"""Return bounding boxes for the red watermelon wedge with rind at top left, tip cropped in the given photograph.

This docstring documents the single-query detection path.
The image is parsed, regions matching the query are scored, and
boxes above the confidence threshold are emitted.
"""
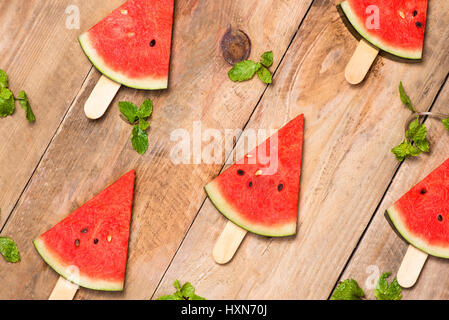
[79,0,174,90]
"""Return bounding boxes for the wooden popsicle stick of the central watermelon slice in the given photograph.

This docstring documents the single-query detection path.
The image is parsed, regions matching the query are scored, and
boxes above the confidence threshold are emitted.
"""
[212,221,248,264]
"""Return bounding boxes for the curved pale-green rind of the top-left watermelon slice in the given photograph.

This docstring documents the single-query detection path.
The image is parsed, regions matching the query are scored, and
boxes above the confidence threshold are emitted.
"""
[78,32,168,90]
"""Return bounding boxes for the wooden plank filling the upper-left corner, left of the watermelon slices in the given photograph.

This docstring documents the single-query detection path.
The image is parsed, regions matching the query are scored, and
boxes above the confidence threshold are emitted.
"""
[0,0,121,230]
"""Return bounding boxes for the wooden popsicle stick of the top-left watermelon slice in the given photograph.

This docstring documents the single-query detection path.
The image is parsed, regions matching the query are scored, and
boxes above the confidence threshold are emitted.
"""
[84,76,121,120]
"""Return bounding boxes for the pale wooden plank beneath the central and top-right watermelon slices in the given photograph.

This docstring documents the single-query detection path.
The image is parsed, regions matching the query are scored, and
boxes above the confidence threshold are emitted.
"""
[154,0,449,299]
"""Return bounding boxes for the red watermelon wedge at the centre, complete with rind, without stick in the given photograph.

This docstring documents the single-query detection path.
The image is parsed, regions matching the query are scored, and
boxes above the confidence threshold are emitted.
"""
[205,115,304,237]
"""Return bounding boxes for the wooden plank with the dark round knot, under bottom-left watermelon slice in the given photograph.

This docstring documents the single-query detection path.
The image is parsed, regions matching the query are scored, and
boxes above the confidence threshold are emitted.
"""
[0,0,311,299]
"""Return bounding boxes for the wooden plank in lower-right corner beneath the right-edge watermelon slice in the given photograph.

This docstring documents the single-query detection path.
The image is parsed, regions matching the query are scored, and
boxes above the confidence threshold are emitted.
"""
[341,80,449,300]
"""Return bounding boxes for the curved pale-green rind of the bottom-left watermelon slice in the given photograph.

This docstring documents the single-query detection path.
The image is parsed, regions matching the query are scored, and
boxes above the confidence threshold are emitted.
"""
[33,238,123,291]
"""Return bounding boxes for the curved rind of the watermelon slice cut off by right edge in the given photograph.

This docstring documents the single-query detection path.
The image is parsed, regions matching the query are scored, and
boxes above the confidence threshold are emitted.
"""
[387,206,449,259]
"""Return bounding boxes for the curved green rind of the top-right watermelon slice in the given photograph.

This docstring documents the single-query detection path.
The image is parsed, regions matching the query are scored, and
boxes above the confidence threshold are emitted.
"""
[339,1,422,60]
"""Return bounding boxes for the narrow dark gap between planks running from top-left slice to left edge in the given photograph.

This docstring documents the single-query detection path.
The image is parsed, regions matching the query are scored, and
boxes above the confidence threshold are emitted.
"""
[0,66,94,234]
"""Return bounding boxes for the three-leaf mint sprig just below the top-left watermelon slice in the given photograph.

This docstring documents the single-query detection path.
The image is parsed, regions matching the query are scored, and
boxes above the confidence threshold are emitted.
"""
[118,99,153,155]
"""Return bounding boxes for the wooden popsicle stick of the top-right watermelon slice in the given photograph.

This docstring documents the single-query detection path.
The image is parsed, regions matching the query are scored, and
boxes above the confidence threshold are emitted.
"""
[345,39,379,84]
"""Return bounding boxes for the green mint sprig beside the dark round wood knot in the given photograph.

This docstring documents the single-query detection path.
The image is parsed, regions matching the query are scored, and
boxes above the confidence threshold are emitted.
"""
[228,51,273,84]
